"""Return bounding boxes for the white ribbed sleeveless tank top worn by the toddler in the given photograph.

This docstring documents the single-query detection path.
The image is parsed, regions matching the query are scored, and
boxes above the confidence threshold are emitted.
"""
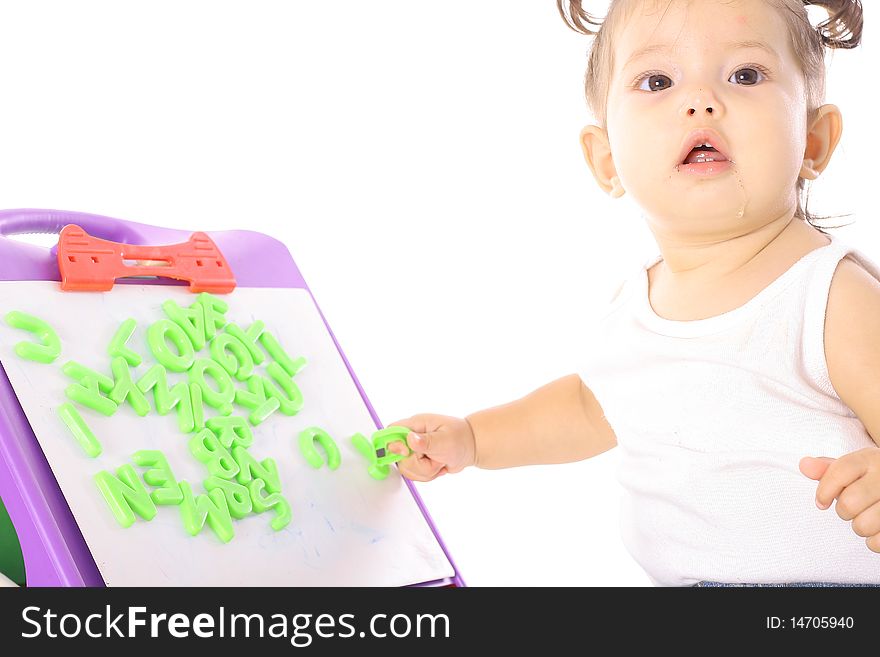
[580,236,880,586]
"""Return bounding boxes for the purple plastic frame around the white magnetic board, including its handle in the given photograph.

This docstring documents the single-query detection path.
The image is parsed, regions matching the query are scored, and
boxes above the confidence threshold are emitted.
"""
[0,209,465,586]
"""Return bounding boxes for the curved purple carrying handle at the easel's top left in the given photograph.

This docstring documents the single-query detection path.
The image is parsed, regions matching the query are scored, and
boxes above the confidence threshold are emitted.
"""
[0,209,144,244]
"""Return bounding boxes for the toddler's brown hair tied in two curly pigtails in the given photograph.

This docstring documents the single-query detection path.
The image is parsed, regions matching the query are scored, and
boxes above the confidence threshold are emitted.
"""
[556,0,864,233]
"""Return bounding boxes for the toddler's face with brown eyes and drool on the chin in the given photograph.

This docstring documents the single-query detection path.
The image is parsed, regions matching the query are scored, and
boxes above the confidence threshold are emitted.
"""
[607,0,807,238]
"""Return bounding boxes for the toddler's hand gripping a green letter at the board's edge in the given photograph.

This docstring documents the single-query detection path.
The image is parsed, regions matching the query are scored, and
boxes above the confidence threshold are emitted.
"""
[386,413,476,481]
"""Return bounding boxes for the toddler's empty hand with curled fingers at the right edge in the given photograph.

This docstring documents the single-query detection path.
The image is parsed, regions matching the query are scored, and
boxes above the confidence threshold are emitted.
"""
[798,447,880,552]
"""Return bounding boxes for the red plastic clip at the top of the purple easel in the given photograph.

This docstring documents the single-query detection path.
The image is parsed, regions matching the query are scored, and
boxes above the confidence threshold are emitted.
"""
[58,224,235,294]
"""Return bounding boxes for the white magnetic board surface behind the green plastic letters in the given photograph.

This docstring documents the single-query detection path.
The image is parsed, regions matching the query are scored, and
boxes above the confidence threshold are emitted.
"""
[0,281,454,586]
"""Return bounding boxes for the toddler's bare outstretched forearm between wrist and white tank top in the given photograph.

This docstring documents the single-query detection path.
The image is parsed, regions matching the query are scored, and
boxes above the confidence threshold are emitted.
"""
[465,374,617,469]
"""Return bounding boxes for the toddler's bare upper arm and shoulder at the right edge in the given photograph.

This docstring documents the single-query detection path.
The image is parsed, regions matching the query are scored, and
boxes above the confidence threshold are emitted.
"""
[825,256,880,430]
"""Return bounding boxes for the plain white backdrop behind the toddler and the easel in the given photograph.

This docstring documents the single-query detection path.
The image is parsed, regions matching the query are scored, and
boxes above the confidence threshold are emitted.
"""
[0,0,880,586]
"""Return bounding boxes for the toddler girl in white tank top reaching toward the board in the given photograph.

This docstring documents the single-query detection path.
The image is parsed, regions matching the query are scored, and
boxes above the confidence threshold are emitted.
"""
[391,0,880,586]
